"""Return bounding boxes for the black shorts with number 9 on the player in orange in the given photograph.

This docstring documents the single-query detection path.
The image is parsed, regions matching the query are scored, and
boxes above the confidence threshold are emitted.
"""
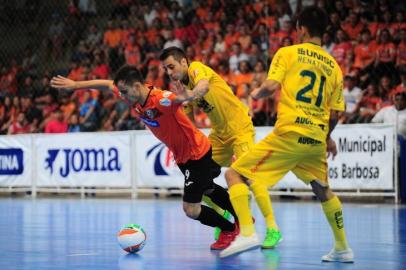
[178,148,221,203]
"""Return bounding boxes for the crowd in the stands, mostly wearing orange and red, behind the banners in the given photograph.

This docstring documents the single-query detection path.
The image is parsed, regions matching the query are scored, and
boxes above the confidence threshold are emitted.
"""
[0,0,406,134]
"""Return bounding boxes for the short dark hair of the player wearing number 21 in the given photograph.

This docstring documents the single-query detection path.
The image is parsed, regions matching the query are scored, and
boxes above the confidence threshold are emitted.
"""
[297,6,328,38]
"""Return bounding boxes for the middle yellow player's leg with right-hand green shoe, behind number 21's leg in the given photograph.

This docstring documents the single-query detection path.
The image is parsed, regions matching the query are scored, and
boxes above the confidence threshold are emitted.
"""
[233,131,282,249]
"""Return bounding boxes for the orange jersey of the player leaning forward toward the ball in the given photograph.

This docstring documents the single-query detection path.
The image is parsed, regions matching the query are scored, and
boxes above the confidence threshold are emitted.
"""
[114,87,211,164]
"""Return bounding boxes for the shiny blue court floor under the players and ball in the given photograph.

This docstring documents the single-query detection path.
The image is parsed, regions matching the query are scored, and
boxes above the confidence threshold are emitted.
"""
[0,198,406,270]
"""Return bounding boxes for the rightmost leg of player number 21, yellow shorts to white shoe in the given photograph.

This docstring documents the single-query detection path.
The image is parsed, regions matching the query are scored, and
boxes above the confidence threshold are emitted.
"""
[292,140,354,262]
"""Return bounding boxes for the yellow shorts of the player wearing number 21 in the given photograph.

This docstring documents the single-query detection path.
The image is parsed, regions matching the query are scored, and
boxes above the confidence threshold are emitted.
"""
[231,132,328,186]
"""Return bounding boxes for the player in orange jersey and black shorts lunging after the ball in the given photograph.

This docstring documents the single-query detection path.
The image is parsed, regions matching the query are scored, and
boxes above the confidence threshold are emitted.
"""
[51,66,239,249]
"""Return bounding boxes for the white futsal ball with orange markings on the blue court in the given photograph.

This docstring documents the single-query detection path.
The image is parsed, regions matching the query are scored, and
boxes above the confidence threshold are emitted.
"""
[117,224,147,253]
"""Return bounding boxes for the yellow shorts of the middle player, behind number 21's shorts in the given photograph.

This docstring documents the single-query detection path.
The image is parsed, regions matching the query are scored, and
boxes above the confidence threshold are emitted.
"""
[209,129,255,167]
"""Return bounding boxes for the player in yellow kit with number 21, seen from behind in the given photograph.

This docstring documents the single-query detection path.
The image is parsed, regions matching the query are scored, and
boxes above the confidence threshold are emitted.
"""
[220,7,354,262]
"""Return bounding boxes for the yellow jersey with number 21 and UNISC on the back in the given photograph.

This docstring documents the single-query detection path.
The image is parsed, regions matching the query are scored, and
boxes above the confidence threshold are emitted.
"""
[268,43,345,142]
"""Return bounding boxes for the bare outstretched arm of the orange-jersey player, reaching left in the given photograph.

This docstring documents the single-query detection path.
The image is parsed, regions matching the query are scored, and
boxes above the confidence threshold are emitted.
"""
[51,75,114,91]
